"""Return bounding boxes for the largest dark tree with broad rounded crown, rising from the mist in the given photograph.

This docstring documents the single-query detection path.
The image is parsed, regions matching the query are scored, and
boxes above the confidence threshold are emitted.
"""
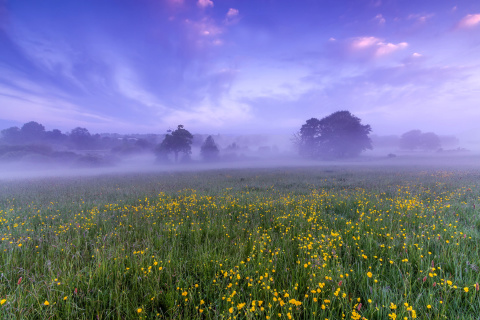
[295,111,372,158]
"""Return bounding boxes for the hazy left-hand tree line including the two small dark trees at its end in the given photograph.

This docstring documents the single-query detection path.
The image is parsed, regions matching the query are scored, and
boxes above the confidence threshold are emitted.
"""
[0,121,219,165]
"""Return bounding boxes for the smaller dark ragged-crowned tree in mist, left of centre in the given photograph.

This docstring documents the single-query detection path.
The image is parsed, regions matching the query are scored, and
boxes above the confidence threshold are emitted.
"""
[156,124,193,162]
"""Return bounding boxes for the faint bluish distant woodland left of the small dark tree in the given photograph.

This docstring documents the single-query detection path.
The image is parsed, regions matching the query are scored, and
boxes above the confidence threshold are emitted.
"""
[0,121,157,167]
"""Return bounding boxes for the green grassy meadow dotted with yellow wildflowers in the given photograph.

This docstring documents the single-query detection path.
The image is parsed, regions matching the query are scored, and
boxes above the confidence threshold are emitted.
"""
[0,166,480,320]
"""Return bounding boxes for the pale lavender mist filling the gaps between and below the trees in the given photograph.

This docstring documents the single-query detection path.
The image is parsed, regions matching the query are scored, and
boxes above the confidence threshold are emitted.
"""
[0,130,480,181]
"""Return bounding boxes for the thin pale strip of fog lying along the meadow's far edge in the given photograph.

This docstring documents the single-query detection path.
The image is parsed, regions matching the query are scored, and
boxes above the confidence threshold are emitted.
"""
[0,150,480,180]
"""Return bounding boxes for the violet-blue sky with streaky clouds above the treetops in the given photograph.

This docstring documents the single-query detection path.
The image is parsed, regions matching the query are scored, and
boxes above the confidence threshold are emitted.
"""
[0,0,480,135]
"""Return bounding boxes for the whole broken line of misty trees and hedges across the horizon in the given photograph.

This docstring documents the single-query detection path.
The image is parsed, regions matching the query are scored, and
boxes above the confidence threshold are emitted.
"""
[0,110,452,163]
